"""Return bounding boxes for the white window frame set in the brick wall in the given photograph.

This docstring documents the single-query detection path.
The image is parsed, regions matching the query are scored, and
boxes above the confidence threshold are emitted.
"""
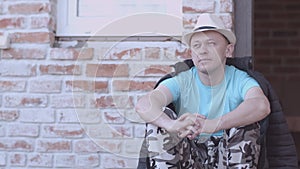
[56,0,183,37]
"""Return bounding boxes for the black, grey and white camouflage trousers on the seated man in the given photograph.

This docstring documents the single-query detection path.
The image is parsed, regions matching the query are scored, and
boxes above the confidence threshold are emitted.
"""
[141,108,260,169]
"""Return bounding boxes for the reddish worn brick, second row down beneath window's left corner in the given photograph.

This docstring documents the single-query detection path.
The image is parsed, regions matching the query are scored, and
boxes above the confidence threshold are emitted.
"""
[39,64,81,75]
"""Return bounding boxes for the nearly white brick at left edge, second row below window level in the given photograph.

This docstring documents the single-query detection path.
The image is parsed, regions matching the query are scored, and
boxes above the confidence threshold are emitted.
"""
[0,61,36,77]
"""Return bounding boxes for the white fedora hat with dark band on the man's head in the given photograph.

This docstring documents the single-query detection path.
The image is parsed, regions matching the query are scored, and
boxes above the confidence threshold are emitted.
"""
[182,13,236,46]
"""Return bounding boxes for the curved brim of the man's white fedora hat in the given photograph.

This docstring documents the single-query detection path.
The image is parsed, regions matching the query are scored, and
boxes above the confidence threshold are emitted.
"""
[182,29,236,46]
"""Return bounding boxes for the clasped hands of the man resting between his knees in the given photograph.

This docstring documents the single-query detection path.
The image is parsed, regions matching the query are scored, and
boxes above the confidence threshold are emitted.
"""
[166,113,217,139]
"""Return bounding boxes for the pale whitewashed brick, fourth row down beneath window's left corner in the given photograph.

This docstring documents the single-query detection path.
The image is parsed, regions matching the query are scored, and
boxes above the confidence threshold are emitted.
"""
[51,95,85,108]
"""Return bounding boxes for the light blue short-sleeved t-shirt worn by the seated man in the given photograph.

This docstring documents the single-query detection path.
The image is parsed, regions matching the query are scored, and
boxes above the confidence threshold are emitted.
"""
[161,65,259,136]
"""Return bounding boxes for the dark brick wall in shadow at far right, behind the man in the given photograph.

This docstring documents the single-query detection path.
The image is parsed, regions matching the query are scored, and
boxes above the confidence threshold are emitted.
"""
[254,0,300,115]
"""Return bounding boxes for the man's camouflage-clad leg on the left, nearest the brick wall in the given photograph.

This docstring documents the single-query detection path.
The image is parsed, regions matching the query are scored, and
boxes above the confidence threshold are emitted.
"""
[146,109,207,169]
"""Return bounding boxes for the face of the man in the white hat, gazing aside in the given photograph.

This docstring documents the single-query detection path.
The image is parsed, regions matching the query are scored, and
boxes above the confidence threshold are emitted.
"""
[190,31,234,74]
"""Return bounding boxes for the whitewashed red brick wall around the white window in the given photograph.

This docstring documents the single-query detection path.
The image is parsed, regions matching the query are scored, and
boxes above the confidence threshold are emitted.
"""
[0,0,233,169]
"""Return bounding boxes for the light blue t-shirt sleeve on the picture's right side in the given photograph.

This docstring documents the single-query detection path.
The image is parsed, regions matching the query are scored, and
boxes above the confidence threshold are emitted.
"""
[239,72,259,99]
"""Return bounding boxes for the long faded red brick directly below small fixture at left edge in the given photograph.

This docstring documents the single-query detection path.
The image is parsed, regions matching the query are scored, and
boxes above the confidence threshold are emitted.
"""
[2,48,46,59]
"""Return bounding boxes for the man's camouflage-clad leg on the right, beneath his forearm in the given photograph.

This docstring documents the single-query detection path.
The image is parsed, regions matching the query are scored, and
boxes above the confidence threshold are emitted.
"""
[218,123,260,169]
